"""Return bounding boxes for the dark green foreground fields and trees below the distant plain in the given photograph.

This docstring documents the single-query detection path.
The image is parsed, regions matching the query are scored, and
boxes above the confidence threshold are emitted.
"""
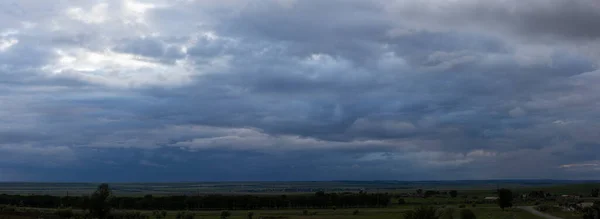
[0,184,600,219]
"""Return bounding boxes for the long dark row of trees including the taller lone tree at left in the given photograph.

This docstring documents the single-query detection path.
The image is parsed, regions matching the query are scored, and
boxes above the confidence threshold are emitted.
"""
[0,184,391,210]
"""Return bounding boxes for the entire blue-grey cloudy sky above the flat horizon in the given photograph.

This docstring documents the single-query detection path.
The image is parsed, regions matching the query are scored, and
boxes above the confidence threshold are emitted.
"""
[0,0,600,182]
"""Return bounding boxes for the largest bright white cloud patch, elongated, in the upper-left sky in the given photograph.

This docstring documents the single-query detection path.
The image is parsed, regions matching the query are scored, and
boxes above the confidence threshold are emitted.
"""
[43,49,199,88]
